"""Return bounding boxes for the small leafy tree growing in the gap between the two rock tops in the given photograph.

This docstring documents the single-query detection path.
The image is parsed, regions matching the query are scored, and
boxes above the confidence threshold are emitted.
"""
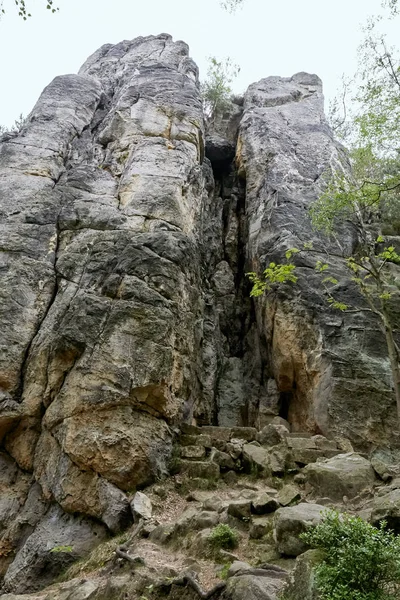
[201,56,240,123]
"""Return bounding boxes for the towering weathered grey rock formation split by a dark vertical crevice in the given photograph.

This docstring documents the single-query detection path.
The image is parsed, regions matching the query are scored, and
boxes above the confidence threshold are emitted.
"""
[0,34,396,598]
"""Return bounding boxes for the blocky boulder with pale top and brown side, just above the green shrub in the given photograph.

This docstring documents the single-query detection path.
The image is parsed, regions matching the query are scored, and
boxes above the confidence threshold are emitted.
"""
[274,503,326,556]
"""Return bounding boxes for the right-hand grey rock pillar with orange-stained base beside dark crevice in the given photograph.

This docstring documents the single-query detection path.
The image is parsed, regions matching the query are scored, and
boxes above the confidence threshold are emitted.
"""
[236,73,397,446]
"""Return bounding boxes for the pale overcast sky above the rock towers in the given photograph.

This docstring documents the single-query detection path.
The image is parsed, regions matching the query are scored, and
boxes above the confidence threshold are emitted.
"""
[0,0,399,126]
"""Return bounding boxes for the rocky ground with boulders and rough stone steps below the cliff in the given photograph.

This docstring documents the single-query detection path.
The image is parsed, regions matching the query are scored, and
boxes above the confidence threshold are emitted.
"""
[2,418,400,600]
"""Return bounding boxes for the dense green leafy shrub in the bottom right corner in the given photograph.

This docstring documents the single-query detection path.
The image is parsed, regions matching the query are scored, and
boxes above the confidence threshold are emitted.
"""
[300,511,400,600]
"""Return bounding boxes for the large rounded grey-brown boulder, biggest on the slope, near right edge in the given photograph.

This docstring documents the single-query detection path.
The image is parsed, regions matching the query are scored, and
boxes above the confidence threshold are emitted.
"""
[304,453,376,500]
